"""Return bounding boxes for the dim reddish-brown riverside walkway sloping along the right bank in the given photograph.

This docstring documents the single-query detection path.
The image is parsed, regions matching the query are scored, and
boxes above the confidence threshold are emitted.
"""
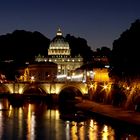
[76,100,140,127]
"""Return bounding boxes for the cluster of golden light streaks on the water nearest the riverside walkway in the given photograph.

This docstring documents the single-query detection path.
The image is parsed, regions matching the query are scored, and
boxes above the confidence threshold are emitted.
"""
[65,119,115,140]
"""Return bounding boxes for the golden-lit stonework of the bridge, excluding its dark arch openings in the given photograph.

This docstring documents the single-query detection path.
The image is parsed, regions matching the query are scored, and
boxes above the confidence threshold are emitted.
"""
[1,81,88,94]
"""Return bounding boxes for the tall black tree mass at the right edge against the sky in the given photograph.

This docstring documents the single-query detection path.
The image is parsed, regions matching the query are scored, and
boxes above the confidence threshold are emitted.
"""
[111,20,140,78]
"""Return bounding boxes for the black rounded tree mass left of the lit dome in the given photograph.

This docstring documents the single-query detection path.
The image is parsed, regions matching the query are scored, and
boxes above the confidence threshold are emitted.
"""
[0,30,50,63]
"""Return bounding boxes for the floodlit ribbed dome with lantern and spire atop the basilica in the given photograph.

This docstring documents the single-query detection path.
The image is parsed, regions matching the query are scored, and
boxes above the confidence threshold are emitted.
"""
[48,28,70,56]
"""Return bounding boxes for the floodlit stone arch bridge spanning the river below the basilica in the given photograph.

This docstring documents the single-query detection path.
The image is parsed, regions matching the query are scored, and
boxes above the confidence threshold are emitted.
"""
[0,82,88,95]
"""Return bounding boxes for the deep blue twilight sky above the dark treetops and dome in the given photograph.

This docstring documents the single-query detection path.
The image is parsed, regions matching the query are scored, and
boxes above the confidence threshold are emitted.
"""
[0,0,140,50]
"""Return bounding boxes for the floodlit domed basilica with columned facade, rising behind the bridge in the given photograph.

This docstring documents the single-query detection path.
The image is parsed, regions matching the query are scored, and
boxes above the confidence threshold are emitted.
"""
[35,28,83,78]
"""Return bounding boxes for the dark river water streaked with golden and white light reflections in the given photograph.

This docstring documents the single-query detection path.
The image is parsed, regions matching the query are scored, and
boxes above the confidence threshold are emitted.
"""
[0,98,140,140]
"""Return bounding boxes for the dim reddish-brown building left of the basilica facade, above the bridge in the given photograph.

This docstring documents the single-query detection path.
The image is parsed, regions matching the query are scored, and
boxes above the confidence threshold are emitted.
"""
[19,62,57,82]
